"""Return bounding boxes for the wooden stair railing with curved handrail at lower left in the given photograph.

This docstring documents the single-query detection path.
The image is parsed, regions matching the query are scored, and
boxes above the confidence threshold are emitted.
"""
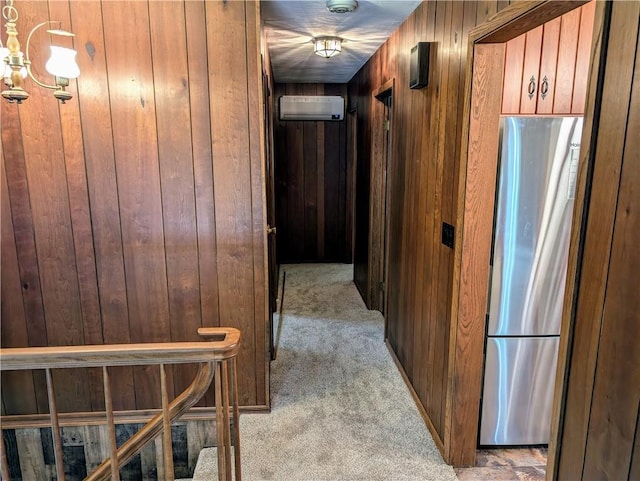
[0,327,241,481]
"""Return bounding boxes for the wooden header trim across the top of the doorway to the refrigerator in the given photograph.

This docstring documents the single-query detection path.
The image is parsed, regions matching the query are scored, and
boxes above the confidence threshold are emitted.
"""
[469,0,588,43]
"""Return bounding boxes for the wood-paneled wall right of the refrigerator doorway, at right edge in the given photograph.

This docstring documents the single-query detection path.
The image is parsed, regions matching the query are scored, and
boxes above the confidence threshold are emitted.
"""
[548,2,640,480]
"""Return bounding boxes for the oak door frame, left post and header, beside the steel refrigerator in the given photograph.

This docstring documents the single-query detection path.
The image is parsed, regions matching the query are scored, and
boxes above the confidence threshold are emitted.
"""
[444,1,597,466]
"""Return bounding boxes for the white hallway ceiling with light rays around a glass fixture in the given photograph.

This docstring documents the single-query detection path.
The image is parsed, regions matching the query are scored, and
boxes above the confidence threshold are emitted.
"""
[262,0,421,83]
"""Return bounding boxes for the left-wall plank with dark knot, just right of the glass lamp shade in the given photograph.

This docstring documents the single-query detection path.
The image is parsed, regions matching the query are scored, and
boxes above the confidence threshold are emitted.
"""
[69,2,136,410]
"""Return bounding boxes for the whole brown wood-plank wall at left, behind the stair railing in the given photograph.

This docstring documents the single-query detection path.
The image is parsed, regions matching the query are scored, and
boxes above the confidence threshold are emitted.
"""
[0,0,268,414]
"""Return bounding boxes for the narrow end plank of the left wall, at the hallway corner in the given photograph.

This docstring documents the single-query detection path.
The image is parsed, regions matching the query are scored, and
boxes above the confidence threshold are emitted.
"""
[245,2,271,405]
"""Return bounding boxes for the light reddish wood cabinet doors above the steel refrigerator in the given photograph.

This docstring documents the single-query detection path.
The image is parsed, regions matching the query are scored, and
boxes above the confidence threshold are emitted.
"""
[502,0,595,115]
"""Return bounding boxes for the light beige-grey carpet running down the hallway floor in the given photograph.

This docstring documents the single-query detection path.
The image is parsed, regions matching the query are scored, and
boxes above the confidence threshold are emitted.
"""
[194,264,457,481]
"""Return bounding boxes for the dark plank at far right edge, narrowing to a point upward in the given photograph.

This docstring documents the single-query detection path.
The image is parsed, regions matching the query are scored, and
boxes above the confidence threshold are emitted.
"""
[582,44,640,472]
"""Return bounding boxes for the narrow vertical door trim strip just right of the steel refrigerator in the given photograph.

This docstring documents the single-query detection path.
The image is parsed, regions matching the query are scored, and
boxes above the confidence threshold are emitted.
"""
[546,2,607,481]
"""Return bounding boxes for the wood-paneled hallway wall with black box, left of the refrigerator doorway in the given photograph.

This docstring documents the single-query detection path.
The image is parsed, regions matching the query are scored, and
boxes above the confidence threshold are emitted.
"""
[349,0,508,446]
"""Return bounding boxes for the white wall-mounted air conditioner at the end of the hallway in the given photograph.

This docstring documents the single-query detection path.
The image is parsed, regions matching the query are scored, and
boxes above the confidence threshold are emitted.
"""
[280,95,344,120]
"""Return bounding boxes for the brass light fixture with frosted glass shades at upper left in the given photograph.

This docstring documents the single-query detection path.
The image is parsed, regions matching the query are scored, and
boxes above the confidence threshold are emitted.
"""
[0,0,80,104]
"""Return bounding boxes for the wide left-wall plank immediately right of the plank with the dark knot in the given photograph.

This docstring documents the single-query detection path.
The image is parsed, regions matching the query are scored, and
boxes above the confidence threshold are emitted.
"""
[102,2,173,409]
